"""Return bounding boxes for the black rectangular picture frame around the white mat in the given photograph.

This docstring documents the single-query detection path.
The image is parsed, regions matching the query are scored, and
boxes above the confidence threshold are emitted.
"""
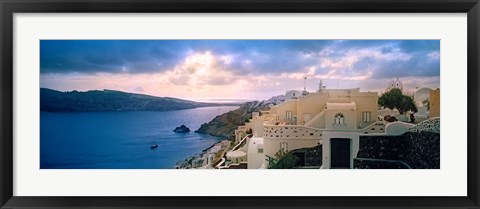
[0,0,480,208]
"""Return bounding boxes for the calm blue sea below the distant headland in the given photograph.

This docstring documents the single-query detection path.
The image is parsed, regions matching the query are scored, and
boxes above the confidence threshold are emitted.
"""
[40,106,237,169]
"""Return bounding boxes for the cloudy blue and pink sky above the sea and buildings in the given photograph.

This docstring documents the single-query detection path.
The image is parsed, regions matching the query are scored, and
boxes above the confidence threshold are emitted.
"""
[40,40,440,101]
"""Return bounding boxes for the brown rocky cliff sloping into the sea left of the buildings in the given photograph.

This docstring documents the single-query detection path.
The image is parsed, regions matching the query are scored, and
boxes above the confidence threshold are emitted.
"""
[195,96,283,138]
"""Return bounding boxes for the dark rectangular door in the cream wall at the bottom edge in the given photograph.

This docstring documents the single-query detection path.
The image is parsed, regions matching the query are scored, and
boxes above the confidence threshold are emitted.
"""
[330,138,352,168]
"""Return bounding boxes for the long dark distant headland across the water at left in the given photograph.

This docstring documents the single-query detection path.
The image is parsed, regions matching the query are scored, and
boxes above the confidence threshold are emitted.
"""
[40,88,238,112]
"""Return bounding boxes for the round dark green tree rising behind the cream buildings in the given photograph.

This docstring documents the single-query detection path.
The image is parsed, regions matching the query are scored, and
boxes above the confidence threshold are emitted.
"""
[378,88,418,115]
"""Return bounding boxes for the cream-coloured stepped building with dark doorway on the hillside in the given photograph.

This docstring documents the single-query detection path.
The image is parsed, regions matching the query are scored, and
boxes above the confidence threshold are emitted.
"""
[223,83,396,169]
